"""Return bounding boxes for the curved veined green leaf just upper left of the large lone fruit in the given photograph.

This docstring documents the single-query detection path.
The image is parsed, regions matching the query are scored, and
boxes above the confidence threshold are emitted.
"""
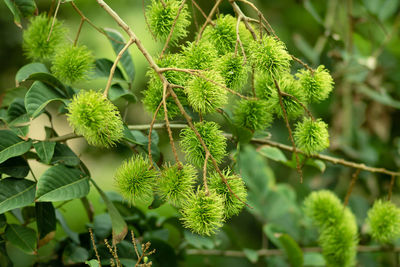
[25,81,68,118]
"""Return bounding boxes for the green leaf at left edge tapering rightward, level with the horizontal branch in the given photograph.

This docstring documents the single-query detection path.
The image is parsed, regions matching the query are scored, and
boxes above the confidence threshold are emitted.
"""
[0,130,32,163]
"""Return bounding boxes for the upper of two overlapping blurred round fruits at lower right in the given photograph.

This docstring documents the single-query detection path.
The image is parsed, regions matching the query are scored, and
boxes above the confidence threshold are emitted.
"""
[304,190,343,228]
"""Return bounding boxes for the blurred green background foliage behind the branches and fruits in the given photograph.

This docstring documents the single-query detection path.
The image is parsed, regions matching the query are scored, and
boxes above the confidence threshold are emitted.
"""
[0,0,400,266]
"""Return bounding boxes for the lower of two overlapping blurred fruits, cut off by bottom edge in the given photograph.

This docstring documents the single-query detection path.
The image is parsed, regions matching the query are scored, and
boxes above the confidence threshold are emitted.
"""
[319,218,358,267]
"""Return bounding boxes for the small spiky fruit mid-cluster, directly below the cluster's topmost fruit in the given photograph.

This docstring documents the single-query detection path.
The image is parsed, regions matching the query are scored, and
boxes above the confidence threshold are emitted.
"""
[218,53,249,91]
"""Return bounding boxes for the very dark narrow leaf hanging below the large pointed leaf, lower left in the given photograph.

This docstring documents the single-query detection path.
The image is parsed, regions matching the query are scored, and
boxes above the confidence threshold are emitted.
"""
[35,202,56,242]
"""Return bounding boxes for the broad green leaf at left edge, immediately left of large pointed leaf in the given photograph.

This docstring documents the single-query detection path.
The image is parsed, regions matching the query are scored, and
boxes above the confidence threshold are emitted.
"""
[0,178,36,213]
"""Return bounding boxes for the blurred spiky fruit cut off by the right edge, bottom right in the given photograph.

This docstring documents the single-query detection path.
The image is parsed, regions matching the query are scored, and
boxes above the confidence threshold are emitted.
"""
[367,200,400,243]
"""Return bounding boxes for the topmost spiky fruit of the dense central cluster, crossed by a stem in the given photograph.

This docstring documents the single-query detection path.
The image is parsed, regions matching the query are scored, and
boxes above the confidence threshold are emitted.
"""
[203,15,251,55]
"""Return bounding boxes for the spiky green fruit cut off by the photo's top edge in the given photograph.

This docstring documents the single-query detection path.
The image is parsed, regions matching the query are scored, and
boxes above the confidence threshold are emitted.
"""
[146,0,190,44]
